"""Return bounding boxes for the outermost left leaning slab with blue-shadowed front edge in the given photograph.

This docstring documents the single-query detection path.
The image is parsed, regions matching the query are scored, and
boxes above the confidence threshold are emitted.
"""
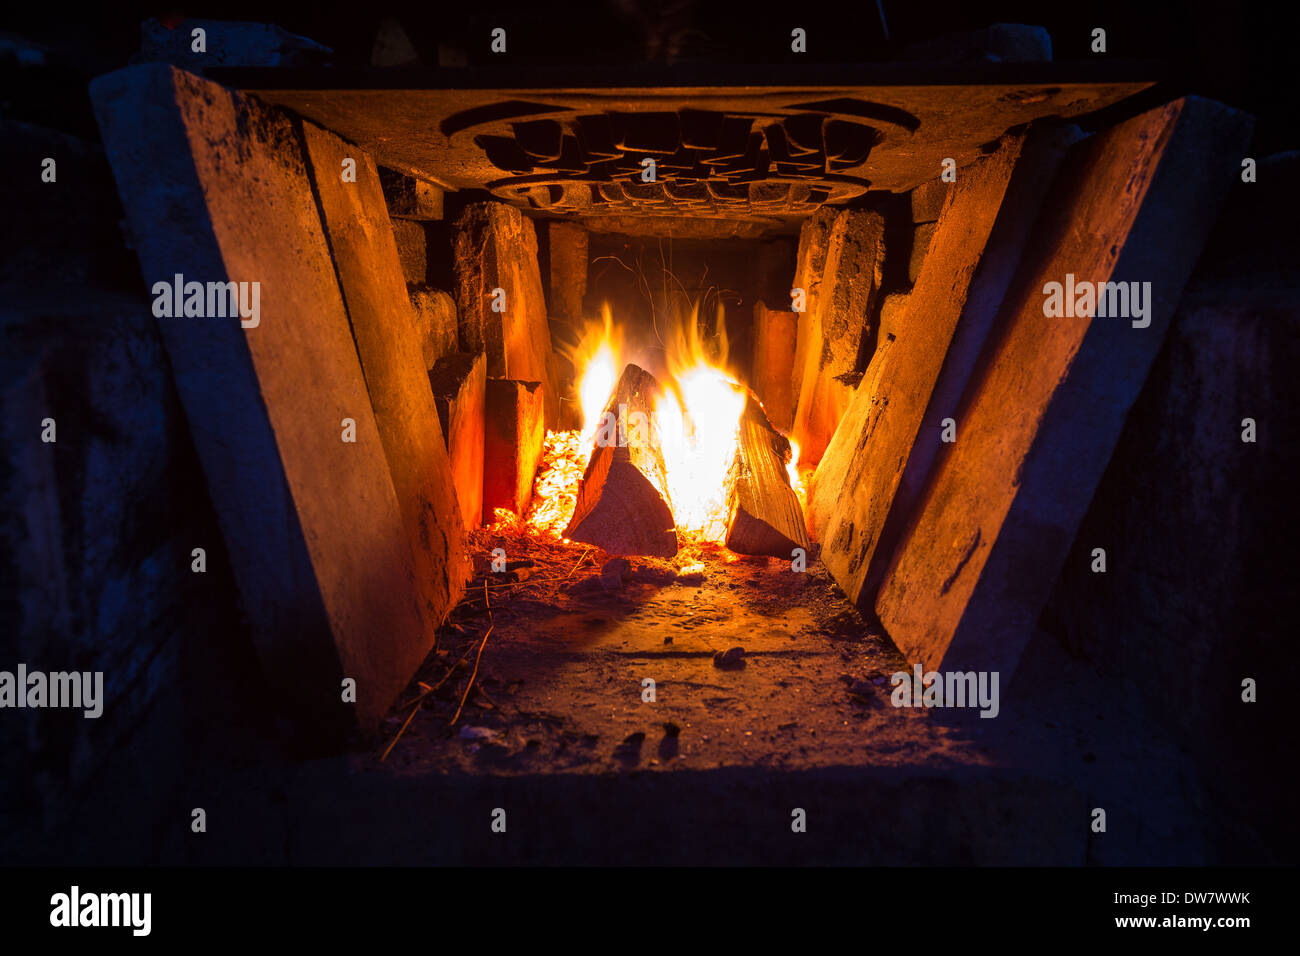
[91,65,429,740]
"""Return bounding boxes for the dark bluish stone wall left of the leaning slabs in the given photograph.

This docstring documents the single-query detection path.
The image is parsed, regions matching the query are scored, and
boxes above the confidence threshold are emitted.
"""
[0,124,265,864]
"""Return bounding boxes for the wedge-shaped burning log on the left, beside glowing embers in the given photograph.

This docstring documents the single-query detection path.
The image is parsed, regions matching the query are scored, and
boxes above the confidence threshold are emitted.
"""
[564,364,677,558]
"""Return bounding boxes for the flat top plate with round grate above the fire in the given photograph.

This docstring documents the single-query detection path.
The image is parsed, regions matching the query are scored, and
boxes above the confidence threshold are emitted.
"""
[222,71,1156,234]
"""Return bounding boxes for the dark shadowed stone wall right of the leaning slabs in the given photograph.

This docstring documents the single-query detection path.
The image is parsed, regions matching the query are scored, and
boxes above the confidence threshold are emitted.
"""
[1043,153,1300,862]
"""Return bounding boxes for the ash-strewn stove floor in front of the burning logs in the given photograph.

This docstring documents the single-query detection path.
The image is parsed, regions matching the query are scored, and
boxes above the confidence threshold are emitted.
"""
[384,532,985,774]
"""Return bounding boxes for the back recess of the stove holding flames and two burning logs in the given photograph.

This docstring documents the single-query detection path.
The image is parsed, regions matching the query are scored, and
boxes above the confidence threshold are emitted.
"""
[517,237,809,563]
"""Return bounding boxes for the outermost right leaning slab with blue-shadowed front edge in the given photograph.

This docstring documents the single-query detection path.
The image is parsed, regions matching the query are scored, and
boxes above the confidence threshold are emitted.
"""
[876,98,1252,679]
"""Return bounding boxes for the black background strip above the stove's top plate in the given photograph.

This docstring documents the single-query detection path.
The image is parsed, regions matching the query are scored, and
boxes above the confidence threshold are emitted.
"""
[0,0,1300,155]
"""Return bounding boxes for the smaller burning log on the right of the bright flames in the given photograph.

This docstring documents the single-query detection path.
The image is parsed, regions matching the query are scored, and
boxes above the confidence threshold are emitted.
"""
[724,395,809,558]
